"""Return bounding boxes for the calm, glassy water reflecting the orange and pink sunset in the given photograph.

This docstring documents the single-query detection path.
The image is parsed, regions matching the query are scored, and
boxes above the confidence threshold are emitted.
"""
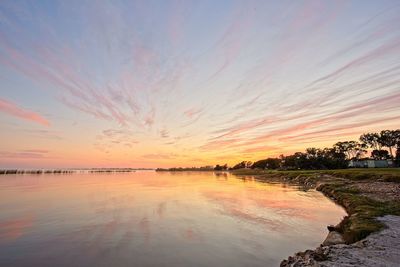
[0,172,345,266]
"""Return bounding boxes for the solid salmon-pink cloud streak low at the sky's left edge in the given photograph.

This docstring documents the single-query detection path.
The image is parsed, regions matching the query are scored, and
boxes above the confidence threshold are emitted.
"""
[0,98,50,126]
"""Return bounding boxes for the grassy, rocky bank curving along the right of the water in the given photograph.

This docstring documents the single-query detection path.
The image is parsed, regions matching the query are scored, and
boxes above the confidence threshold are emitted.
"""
[228,169,400,267]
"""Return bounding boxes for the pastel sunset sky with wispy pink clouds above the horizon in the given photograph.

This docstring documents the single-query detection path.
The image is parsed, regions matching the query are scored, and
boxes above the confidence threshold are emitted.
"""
[0,0,400,168]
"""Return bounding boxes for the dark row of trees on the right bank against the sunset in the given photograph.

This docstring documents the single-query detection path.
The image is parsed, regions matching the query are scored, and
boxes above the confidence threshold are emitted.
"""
[222,129,400,170]
